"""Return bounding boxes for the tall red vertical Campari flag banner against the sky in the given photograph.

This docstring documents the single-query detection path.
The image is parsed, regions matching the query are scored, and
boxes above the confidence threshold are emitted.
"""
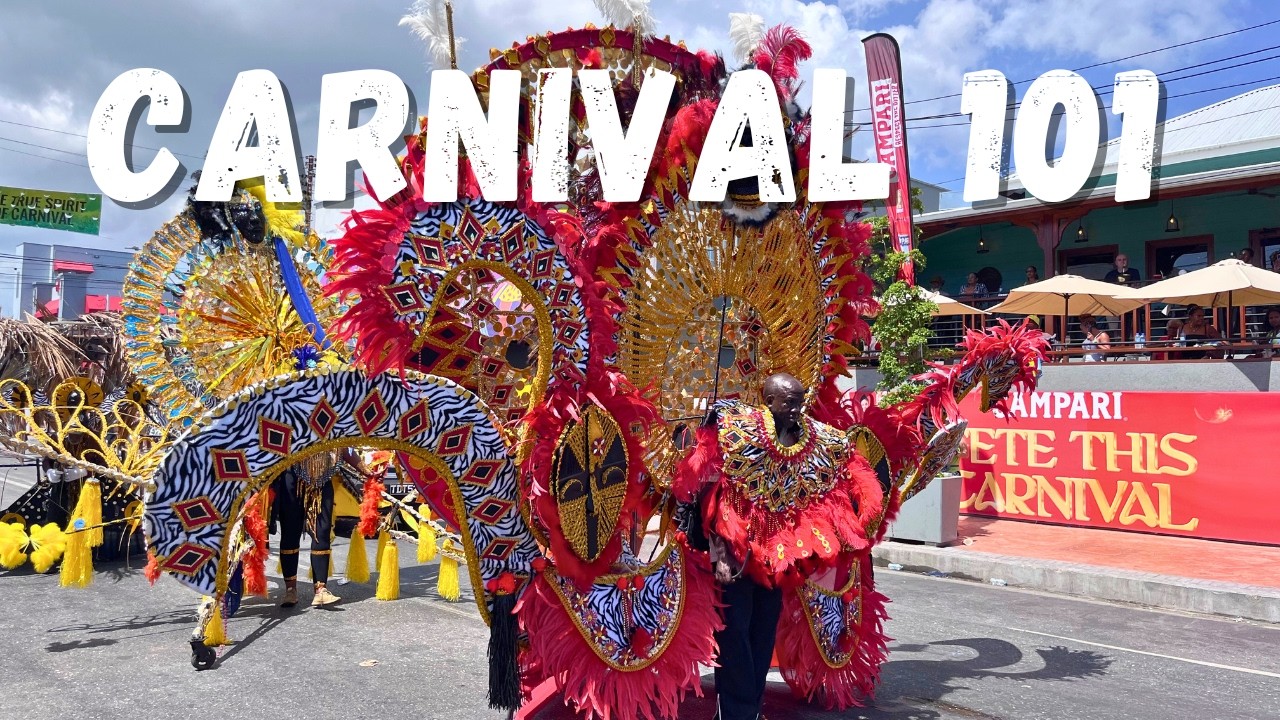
[863,32,915,284]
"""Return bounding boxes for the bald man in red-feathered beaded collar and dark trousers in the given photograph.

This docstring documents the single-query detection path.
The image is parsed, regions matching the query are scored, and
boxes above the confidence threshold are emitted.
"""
[676,373,881,720]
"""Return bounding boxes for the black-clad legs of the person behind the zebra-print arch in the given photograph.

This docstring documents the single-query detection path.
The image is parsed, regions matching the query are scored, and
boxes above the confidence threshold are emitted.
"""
[273,455,340,607]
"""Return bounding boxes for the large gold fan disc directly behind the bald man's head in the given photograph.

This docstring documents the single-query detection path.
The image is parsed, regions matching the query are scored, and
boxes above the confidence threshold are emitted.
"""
[618,198,826,483]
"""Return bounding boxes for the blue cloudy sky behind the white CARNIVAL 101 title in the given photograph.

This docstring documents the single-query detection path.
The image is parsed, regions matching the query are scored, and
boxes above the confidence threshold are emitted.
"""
[0,0,1264,301]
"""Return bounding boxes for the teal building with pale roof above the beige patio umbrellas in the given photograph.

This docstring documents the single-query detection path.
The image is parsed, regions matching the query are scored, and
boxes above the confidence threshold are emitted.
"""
[916,85,1280,295]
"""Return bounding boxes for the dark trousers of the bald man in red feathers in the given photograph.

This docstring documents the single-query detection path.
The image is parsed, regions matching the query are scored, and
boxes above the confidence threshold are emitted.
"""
[716,575,782,720]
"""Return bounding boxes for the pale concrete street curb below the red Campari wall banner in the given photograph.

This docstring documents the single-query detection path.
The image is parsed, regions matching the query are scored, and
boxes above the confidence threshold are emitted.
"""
[872,541,1280,623]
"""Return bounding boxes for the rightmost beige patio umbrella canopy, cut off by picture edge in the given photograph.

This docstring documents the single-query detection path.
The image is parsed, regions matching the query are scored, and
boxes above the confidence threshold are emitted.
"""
[1120,258,1280,338]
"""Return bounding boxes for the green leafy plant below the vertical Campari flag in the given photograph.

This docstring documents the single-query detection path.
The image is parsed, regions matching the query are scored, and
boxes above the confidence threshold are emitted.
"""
[867,184,936,406]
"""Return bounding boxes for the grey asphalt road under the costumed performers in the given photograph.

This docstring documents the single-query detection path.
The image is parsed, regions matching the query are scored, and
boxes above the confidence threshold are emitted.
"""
[0,471,1280,720]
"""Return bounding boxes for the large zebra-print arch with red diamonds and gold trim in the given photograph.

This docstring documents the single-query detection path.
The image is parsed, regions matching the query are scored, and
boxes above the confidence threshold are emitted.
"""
[146,369,538,612]
